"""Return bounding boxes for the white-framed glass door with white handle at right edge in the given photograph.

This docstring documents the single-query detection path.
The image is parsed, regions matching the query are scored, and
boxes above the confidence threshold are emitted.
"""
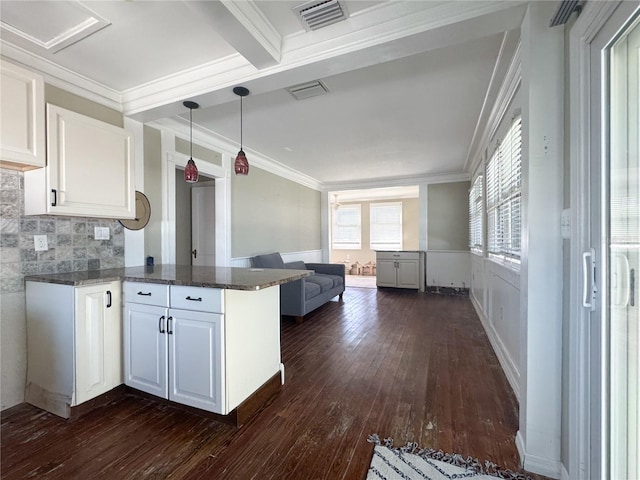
[584,2,640,479]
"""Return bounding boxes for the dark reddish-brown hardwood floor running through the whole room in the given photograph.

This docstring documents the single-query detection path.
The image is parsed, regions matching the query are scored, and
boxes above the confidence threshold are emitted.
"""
[0,288,542,480]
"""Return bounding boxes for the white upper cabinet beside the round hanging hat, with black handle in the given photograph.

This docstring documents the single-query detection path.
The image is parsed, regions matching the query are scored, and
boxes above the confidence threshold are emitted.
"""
[24,104,135,219]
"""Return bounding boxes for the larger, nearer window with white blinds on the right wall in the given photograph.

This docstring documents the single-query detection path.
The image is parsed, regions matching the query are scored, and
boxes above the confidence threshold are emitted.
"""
[487,117,522,258]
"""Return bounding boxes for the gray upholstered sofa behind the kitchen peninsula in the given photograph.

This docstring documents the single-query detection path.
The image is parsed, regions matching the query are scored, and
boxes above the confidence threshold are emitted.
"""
[251,253,344,323]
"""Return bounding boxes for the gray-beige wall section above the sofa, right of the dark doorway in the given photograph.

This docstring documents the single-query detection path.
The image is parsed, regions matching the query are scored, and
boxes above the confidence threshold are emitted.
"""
[231,167,321,258]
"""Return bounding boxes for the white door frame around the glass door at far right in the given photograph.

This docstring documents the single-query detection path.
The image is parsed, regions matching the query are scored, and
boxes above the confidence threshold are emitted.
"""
[562,1,638,480]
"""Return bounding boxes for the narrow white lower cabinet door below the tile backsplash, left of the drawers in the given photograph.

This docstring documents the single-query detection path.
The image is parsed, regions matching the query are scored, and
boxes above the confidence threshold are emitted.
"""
[73,282,122,405]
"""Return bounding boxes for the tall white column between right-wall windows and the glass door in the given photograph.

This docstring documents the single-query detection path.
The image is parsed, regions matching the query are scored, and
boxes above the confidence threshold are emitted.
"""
[516,2,564,478]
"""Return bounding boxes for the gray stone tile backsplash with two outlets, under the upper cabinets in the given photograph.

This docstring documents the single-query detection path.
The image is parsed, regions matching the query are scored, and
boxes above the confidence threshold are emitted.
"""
[0,168,124,293]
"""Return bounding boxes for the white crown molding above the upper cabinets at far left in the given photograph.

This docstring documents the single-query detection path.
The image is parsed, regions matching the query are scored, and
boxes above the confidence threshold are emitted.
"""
[0,38,122,112]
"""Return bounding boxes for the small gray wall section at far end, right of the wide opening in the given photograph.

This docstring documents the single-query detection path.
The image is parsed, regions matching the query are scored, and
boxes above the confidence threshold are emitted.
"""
[427,182,469,251]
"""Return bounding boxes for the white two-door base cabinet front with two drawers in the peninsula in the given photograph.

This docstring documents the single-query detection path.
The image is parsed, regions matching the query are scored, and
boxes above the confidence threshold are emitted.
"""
[124,282,228,414]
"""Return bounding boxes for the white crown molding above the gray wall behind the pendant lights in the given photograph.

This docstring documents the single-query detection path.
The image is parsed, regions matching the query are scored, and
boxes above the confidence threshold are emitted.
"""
[146,117,322,191]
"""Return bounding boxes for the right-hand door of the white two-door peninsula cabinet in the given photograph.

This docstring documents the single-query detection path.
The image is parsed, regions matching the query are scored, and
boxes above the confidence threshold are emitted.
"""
[168,309,224,413]
